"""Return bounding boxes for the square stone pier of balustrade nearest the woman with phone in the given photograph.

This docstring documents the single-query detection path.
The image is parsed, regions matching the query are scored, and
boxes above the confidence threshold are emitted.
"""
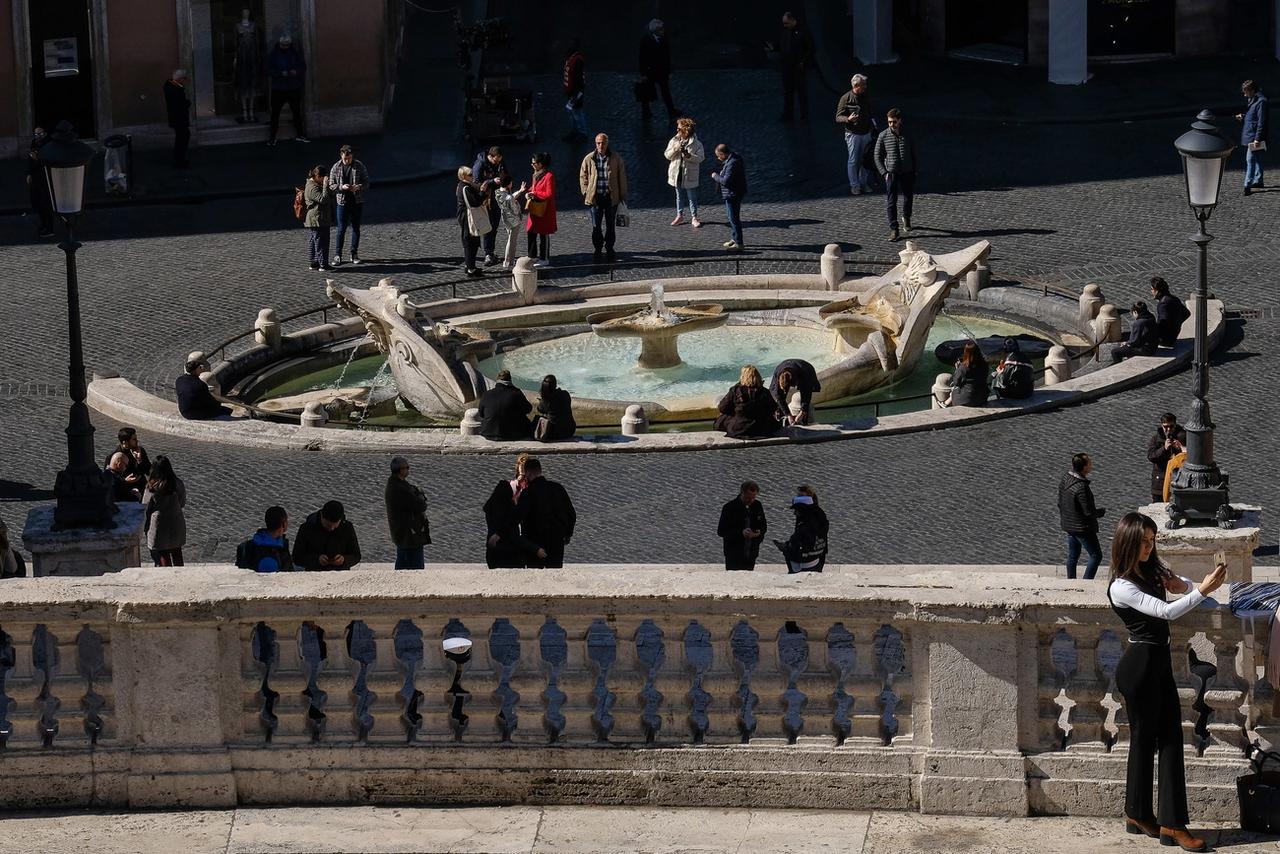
[915,627,1034,816]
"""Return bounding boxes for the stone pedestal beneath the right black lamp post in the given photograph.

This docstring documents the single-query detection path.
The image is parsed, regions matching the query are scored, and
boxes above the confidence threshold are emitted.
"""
[1139,502,1262,588]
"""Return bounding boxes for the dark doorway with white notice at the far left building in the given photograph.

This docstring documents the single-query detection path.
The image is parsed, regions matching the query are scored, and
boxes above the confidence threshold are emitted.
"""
[27,0,97,137]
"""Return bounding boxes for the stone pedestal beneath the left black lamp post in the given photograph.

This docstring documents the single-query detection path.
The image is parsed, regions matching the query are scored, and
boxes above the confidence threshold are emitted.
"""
[22,502,146,576]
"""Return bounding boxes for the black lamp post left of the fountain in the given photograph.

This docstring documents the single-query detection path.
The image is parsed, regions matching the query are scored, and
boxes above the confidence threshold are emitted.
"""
[40,122,115,529]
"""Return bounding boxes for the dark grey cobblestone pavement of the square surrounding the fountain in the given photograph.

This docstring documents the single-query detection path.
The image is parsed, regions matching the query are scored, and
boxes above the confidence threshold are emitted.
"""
[0,72,1280,563]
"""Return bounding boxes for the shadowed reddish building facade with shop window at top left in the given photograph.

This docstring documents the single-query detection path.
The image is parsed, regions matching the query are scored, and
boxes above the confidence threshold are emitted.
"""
[0,0,394,155]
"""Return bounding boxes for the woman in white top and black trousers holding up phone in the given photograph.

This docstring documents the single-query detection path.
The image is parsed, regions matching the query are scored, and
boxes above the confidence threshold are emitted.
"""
[1107,513,1226,851]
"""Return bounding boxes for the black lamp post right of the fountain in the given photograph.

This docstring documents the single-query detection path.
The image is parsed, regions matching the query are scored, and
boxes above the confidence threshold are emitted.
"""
[1169,110,1235,528]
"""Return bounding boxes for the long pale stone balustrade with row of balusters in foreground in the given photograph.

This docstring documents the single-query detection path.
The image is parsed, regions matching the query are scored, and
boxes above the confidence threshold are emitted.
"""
[0,566,1276,819]
